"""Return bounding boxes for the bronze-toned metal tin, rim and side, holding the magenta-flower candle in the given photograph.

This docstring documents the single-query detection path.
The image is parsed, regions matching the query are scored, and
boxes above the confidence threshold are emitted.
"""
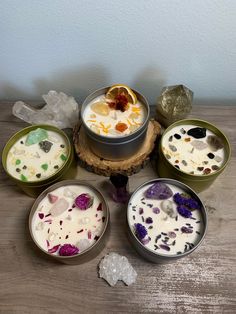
[28,180,110,264]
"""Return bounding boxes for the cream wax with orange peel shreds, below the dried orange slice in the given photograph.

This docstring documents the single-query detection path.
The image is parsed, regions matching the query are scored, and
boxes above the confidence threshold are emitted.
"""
[83,95,147,137]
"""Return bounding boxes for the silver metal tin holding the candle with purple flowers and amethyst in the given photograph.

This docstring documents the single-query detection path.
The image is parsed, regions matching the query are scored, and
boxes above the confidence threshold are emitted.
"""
[126,178,208,263]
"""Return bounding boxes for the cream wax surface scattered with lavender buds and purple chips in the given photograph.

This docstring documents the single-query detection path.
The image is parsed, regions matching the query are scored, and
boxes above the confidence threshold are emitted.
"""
[128,184,203,255]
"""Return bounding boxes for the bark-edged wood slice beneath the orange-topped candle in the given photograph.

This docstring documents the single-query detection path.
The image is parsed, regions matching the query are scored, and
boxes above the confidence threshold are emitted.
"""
[73,120,161,177]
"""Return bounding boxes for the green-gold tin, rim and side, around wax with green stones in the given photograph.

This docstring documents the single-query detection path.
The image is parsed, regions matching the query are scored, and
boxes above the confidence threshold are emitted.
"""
[2,124,74,196]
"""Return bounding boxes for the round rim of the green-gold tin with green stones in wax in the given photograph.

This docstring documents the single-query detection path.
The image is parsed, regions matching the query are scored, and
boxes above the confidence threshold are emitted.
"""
[2,124,72,187]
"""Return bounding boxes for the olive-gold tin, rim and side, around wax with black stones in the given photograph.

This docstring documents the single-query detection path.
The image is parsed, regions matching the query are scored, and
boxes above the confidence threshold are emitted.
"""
[157,119,231,192]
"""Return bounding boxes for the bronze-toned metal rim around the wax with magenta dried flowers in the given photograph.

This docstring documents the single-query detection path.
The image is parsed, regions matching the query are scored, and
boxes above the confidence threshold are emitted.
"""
[28,180,110,261]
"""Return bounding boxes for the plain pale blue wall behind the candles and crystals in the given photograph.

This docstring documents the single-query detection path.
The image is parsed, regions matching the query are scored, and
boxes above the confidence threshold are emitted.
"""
[0,0,236,104]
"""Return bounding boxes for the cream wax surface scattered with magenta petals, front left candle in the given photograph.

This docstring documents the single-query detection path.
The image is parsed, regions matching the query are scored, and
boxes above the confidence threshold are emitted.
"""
[32,185,106,255]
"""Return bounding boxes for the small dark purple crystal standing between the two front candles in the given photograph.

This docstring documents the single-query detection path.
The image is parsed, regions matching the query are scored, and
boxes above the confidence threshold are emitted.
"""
[110,174,130,203]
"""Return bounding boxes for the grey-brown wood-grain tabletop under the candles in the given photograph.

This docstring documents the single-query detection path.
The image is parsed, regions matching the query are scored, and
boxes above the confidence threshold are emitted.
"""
[0,102,236,314]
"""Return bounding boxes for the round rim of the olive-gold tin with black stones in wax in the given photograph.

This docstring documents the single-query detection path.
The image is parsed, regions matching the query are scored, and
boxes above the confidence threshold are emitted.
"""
[160,119,231,181]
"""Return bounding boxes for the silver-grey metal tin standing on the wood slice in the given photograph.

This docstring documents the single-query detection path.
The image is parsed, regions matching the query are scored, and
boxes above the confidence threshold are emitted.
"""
[81,86,150,160]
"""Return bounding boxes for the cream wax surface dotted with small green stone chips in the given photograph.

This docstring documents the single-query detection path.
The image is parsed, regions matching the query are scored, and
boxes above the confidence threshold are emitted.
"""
[6,131,68,181]
